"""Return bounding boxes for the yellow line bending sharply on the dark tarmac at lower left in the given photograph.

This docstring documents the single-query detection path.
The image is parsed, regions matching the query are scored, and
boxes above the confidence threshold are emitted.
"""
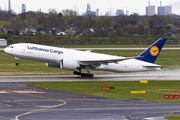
[15,93,66,120]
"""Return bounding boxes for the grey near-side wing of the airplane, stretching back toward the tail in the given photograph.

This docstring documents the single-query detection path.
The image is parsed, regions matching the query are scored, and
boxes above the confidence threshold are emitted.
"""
[78,57,136,67]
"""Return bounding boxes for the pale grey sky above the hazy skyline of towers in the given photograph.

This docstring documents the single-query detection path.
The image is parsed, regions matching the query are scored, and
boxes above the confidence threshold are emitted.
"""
[0,0,180,15]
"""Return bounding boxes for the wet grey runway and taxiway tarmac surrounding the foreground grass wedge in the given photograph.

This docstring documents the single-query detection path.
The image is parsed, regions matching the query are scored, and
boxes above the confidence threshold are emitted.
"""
[0,75,180,120]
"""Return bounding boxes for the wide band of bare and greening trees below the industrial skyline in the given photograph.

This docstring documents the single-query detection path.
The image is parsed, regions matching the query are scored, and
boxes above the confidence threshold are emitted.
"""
[0,9,180,44]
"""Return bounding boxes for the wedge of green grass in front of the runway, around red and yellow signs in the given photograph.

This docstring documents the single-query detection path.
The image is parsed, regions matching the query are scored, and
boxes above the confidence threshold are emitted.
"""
[28,81,180,100]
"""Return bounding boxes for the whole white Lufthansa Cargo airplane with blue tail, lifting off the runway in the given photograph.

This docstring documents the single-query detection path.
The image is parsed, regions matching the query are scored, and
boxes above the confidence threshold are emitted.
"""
[4,38,166,78]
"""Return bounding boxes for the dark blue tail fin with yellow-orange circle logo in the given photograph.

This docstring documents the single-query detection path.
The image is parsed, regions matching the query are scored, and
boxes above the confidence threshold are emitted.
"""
[136,38,167,63]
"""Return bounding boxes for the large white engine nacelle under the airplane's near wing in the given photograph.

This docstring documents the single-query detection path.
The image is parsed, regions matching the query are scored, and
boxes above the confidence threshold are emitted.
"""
[60,58,80,70]
